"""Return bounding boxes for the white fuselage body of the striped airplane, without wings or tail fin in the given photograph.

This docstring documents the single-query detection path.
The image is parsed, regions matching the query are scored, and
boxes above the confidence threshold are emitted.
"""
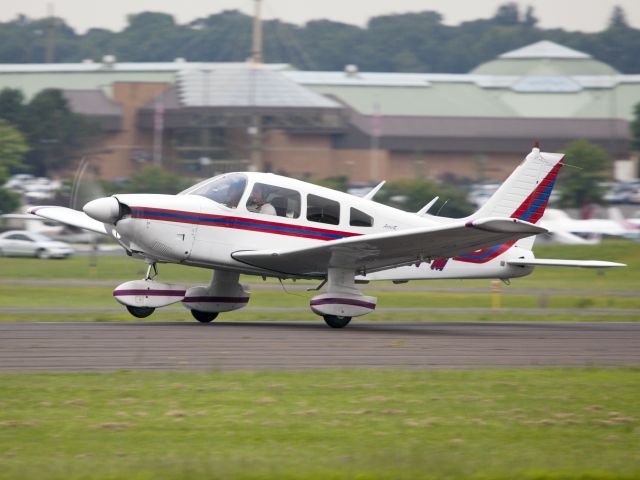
[107,173,532,280]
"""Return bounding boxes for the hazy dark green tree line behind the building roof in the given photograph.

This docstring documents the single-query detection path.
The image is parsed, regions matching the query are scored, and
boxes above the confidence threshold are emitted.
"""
[0,3,640,73]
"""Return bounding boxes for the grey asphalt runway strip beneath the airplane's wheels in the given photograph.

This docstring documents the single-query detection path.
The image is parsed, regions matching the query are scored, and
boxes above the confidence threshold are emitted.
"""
[0,320,640,372]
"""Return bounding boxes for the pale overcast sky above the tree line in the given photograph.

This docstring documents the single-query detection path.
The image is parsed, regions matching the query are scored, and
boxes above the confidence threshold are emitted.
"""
[0,0,640,33]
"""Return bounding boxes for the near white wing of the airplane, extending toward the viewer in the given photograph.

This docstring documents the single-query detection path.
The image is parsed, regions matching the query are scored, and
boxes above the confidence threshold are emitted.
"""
[232,218,547,277]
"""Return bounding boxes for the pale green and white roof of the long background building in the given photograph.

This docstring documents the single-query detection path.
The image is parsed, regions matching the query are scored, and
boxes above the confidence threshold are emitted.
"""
[0,42,640,120]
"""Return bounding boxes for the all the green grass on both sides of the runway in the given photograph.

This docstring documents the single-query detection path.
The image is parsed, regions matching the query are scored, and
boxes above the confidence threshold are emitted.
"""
[0,241,640,480]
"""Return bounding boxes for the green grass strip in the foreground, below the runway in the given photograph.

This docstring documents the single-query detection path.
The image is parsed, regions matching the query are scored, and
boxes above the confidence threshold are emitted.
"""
[0,369,640,479]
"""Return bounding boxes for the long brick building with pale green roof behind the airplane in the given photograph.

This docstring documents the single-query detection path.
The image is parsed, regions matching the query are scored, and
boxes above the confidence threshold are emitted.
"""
[0,41,640,183]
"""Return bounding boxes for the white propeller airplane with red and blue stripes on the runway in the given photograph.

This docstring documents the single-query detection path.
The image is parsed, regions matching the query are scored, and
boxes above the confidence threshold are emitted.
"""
[30,144,624,328]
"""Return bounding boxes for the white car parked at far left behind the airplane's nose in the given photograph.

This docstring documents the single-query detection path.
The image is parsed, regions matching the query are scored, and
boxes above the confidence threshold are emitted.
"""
[0,230,74,258]
